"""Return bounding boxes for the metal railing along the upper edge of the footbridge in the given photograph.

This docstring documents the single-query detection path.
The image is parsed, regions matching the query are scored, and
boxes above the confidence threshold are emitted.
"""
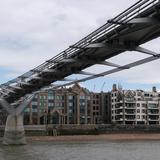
[1,0,160,96]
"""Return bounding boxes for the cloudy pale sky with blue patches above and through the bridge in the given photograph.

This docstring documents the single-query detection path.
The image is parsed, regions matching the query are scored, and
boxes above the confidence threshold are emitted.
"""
[0,0,160,91]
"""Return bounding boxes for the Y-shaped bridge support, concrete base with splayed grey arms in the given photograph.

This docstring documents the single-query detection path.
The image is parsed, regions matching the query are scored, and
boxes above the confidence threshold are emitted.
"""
[0,96,33,145]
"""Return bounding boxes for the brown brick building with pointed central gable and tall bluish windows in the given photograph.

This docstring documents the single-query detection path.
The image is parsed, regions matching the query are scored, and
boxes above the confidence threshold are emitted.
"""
[24,84,94,124]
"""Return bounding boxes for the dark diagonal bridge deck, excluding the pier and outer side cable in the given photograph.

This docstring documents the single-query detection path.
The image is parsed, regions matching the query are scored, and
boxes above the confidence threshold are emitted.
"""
[2,0,160,103]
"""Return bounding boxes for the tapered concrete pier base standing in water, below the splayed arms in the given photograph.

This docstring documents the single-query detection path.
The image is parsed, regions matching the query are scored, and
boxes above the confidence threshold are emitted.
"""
[3,114,26,145]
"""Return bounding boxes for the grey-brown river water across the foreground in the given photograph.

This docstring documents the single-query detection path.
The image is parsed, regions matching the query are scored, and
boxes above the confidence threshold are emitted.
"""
[0,141,160,160]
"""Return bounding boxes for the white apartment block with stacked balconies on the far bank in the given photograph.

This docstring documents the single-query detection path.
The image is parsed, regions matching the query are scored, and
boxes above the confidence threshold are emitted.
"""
[111,85,160,125]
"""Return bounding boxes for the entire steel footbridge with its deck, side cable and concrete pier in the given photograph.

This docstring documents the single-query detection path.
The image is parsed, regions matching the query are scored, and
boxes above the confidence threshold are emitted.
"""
[0,0,160,144]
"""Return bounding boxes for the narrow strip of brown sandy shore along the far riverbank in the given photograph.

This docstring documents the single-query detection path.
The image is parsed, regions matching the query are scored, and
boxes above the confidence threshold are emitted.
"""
[26,133,160,143]
